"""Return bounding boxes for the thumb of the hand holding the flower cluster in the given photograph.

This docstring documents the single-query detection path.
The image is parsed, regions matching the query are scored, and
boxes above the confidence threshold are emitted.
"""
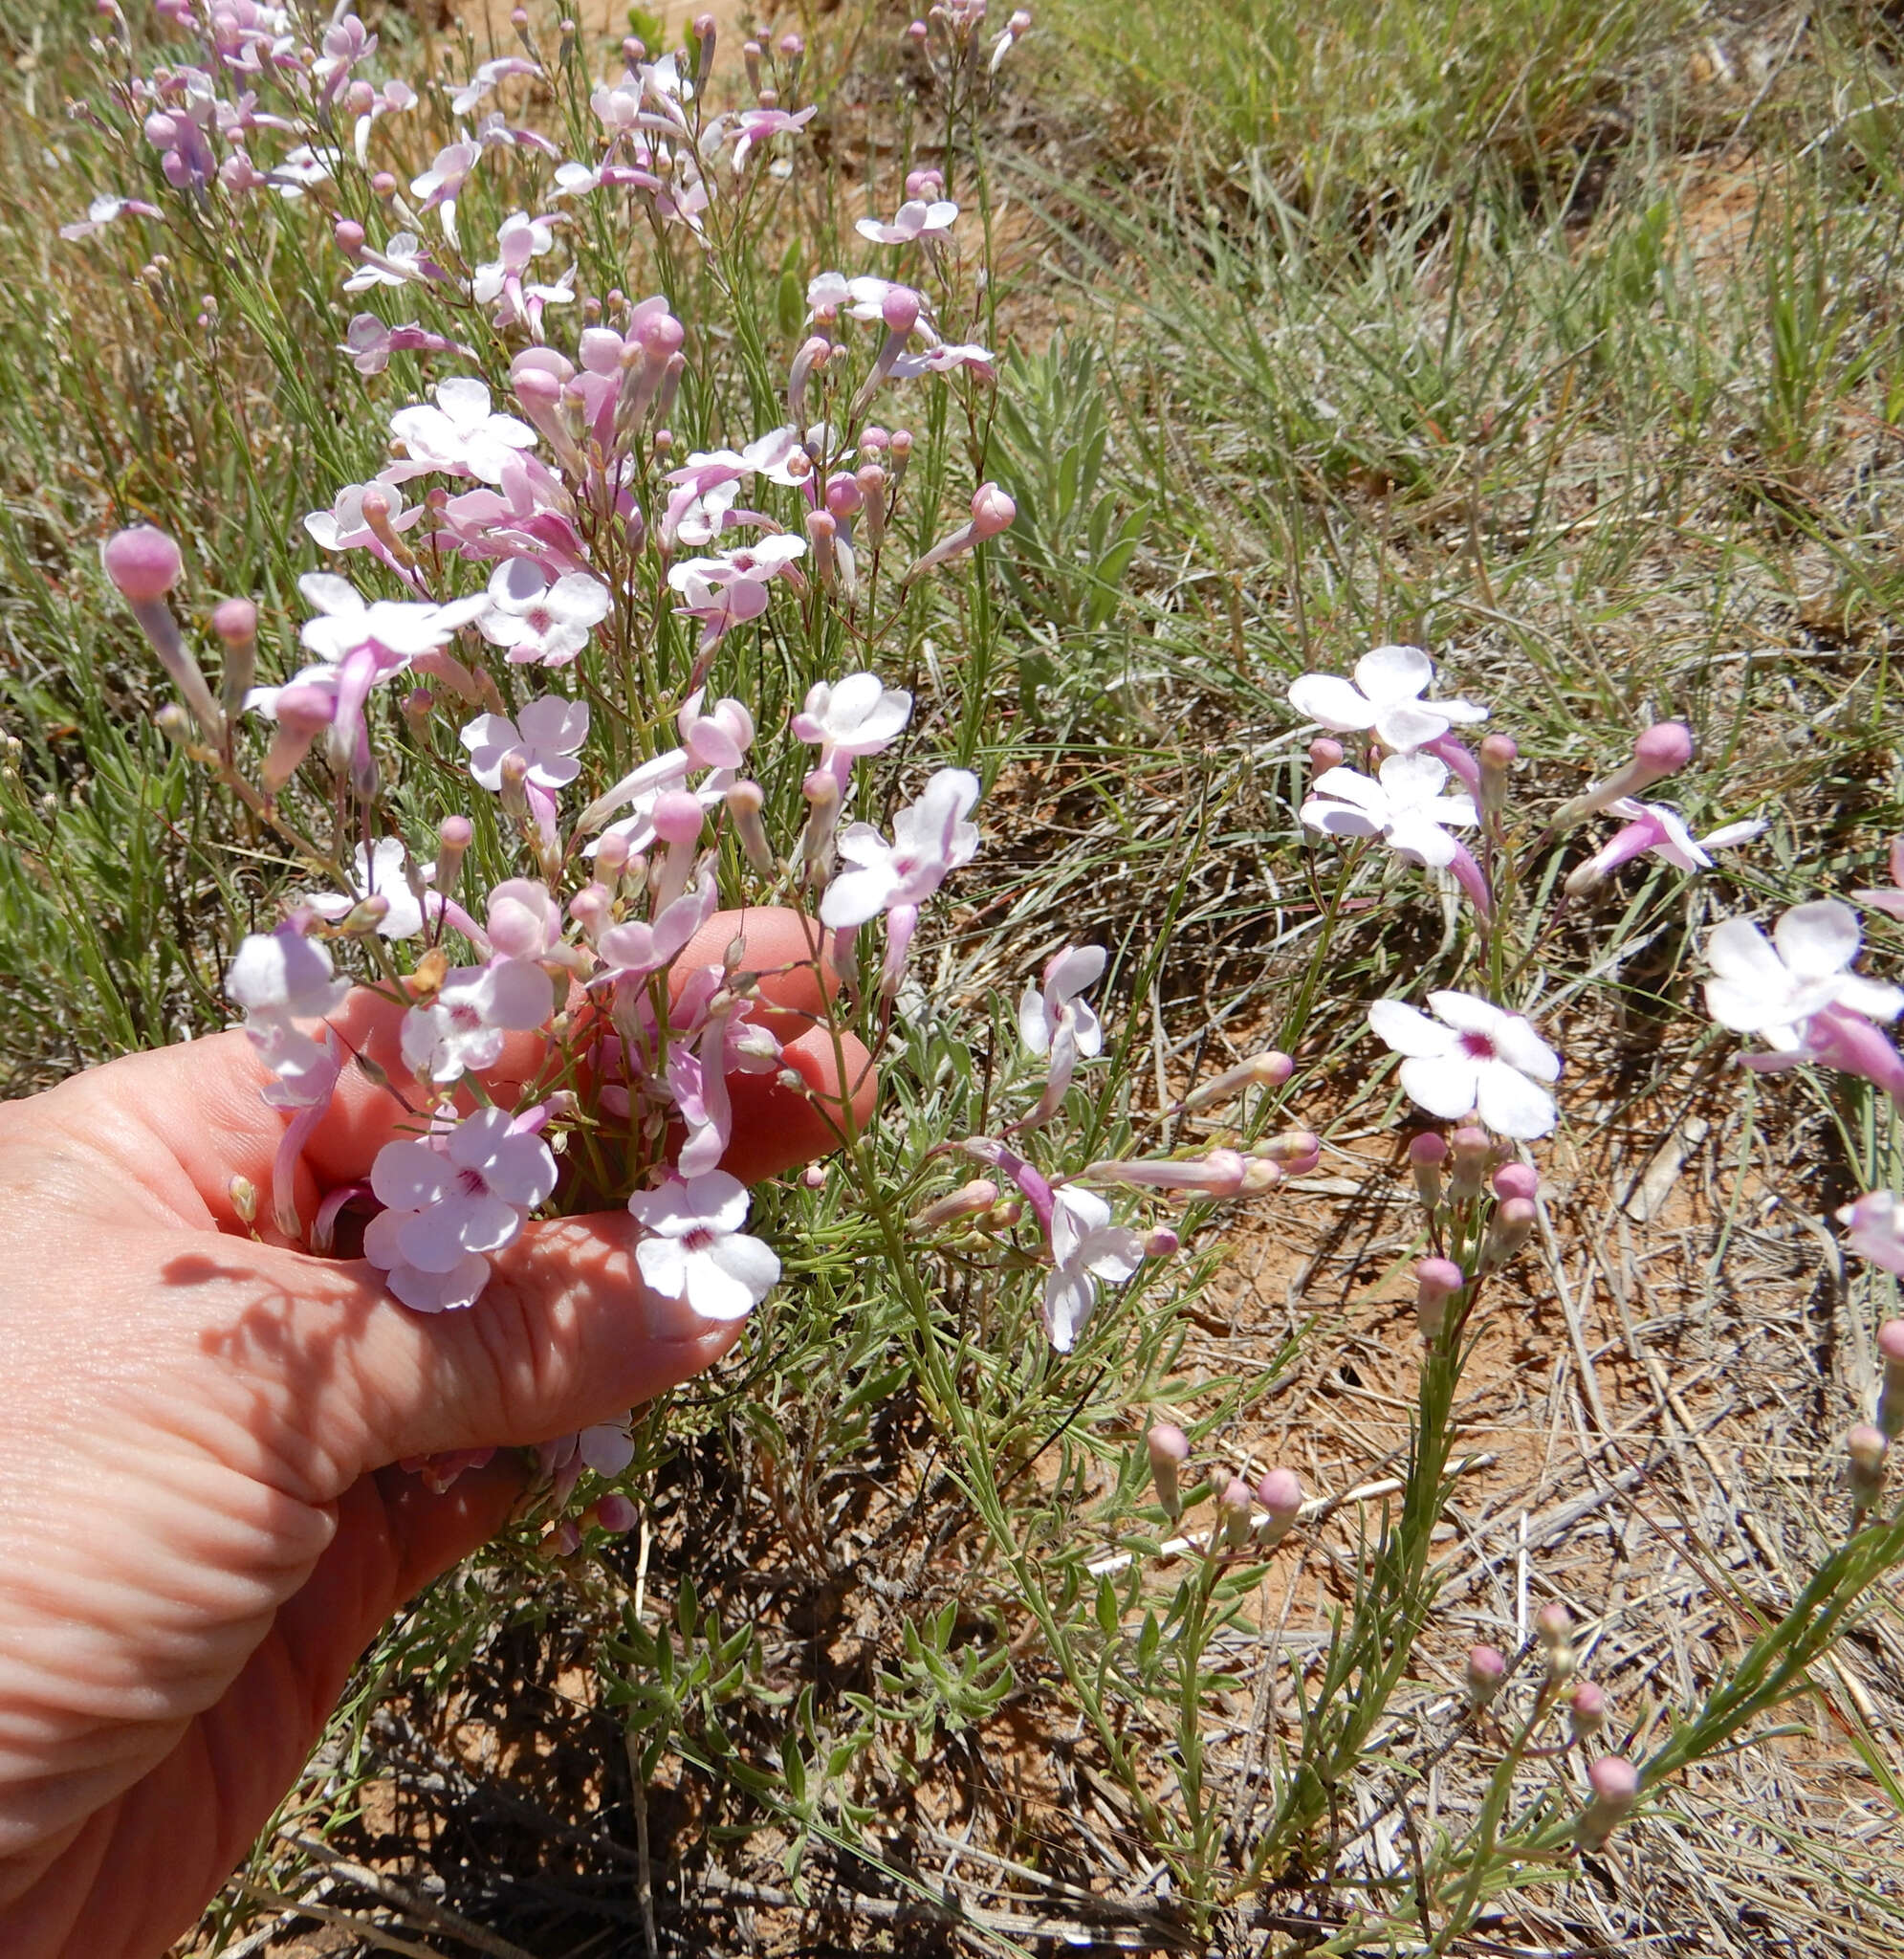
[231,1211,744,1501]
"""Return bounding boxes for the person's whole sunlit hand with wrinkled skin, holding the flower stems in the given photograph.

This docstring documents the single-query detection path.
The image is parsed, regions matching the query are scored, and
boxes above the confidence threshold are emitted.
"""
[0,913,872,1959]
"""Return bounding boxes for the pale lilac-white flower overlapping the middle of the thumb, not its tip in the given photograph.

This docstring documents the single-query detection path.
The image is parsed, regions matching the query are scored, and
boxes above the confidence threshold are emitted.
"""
[364,1109,557,1312]
